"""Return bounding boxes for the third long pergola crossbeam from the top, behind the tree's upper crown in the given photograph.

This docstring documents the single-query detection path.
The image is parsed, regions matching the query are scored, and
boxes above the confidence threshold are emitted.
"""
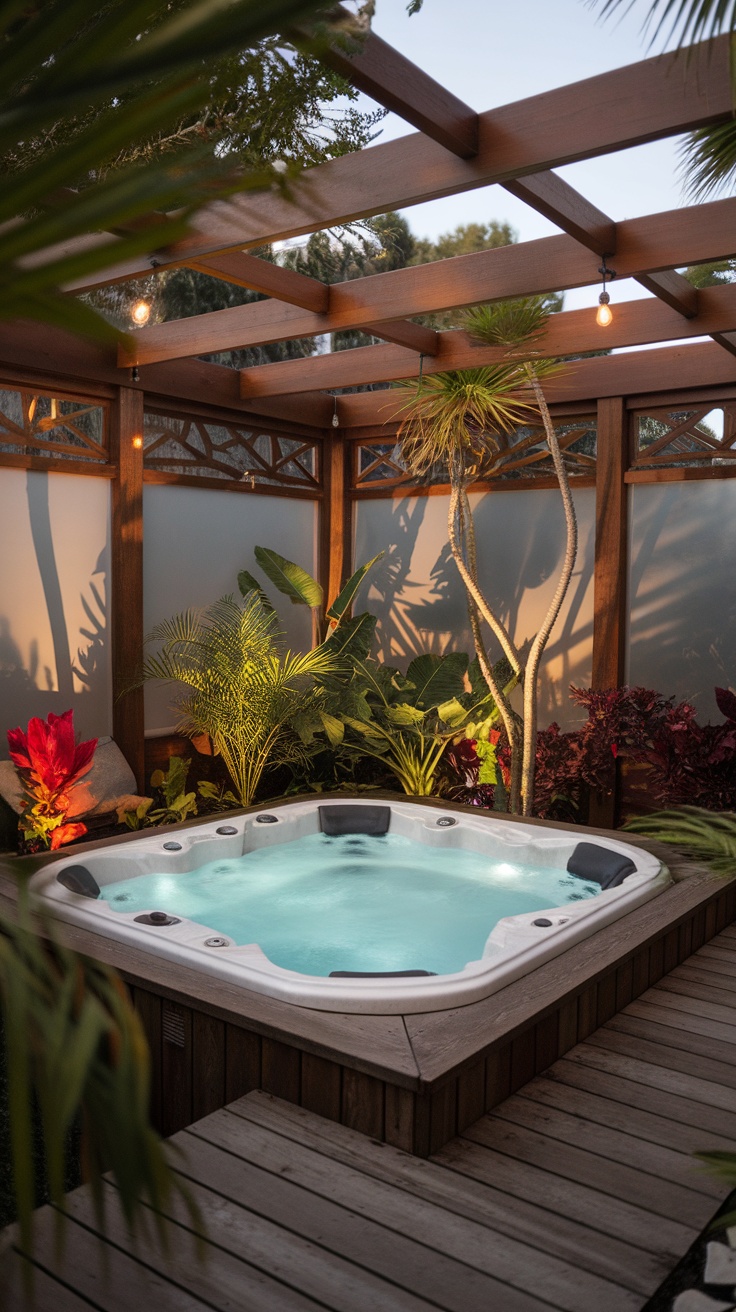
[240,285,736,398]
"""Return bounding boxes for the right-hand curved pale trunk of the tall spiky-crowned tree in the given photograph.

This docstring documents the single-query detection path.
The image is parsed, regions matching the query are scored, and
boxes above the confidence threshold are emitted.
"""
[521,365,577,816]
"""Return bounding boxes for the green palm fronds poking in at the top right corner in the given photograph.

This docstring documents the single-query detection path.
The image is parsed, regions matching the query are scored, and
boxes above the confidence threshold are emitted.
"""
[588,0,736,199]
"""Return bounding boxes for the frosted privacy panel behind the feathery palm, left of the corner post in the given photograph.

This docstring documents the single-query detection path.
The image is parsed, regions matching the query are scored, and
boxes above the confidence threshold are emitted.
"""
[143,484,317,729]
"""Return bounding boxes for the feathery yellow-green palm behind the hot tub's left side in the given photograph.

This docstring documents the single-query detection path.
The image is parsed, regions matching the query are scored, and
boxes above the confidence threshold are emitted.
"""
[143,594,335,807]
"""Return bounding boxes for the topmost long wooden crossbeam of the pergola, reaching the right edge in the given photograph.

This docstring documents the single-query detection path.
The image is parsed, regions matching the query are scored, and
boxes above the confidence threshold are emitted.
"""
[64,35,732,291]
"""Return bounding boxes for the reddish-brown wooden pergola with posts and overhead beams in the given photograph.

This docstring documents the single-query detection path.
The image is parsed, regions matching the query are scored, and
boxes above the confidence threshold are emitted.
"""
[0,23,736,818]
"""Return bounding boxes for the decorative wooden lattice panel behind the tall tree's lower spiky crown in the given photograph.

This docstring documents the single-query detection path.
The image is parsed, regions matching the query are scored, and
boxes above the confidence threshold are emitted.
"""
[353,417,596,491]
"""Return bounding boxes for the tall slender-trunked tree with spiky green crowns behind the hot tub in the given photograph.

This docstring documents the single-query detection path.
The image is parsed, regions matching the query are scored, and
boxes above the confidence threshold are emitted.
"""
[398,297,569,815]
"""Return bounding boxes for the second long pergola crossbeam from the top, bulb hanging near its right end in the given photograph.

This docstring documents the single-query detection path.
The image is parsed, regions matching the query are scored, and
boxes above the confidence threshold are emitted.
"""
[119,198,736,366]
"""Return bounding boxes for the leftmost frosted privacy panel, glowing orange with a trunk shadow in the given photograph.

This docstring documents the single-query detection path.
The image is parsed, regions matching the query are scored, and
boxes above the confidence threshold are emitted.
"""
[0,468,112,757]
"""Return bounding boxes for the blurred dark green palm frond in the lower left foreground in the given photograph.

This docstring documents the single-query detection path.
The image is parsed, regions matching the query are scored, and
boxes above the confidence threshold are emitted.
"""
[0,878,201,1264]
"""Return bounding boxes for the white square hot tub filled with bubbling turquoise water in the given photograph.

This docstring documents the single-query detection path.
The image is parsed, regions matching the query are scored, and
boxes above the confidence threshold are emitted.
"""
[31,799,670,1014]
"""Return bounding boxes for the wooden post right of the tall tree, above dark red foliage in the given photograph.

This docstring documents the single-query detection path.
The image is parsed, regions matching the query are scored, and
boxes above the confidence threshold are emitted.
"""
[589,396,628,828]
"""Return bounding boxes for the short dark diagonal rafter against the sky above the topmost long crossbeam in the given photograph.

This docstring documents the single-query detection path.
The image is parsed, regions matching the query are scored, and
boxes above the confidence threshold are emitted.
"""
[289,7,479,159]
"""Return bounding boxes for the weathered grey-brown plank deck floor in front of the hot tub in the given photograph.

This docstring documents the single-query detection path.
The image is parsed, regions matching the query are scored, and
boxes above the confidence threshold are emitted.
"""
[3,928,736,1312]
